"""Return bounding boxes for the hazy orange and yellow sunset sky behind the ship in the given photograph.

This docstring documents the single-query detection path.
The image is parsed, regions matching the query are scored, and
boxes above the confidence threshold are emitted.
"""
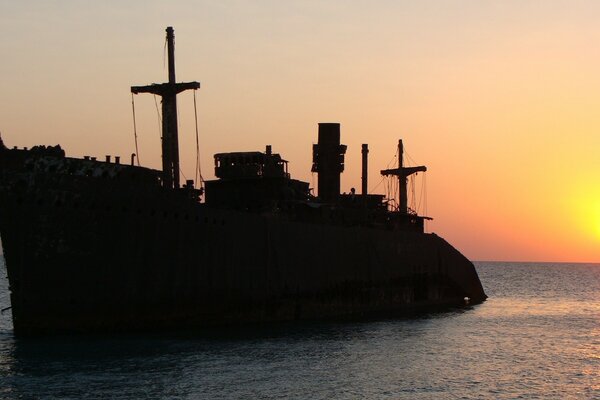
[0,0,600,262]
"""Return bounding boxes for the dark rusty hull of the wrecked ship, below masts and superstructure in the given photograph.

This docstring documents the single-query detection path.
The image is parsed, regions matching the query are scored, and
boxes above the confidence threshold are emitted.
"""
[0,150,485,334]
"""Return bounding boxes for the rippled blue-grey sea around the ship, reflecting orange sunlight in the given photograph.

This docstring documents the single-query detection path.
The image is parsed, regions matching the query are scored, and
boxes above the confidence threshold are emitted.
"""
[0,262,600,399]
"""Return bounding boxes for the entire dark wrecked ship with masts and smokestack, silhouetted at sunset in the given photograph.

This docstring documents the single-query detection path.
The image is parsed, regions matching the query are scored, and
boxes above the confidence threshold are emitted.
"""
[0,27,486,335]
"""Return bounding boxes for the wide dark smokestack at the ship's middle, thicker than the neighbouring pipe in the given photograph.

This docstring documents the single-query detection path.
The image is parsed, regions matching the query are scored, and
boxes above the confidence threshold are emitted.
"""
[312,123,346,203]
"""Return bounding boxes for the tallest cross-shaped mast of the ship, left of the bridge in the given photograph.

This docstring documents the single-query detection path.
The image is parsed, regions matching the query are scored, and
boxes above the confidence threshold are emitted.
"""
[131,26,200,189]
